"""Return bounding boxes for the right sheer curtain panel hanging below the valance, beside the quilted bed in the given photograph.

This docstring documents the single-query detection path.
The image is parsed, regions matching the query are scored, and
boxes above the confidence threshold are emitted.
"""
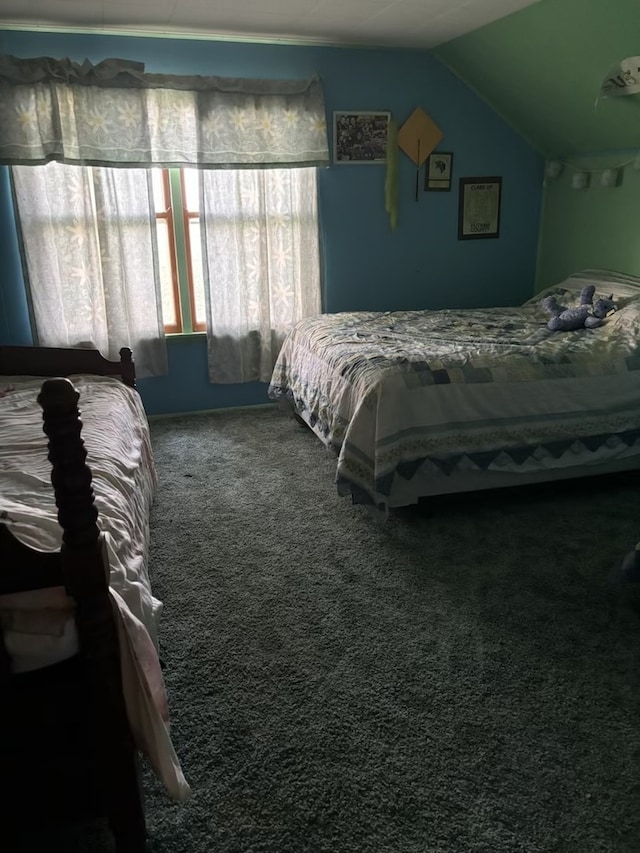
[200,169,321,382]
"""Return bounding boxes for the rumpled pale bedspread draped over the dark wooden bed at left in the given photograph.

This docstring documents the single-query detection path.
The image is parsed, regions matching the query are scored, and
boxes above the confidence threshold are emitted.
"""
[0,376,189,799]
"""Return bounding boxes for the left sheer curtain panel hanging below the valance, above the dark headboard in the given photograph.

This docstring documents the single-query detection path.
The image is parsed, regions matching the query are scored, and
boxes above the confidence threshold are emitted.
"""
[12,163,167,378]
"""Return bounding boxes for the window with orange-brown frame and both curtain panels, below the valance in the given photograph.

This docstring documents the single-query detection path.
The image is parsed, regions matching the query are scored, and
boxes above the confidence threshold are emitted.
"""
[12,162,321,383]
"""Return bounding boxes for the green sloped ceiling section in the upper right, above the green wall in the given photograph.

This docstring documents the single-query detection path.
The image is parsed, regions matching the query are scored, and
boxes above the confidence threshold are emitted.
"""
[434,0,640,158]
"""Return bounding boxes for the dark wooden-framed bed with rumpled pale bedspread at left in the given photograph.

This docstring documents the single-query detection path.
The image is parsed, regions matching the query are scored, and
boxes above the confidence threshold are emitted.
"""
[0,347,189,851]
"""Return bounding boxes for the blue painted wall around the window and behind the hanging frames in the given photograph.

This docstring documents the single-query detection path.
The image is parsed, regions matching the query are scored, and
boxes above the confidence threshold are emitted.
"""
[0,31,543,413]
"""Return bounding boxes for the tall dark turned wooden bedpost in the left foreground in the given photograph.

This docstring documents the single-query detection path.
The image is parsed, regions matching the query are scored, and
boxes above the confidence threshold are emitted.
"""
[38,379,145,853]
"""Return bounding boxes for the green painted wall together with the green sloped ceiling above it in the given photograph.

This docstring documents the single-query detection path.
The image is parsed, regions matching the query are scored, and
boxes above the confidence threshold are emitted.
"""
[435,0,640,290]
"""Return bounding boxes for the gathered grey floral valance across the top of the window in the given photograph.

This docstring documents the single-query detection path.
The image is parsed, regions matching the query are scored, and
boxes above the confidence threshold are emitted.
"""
[0,56,329,169]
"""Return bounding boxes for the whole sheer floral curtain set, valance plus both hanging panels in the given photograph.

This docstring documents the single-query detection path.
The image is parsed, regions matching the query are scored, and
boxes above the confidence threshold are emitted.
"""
[0,56,329,382]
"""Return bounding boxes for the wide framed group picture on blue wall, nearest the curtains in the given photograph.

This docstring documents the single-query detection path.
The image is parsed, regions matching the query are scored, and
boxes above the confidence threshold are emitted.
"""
[333,111,391,164]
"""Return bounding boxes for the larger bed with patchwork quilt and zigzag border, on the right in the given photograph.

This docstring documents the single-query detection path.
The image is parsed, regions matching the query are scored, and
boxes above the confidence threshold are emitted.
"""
[269,270,640,512]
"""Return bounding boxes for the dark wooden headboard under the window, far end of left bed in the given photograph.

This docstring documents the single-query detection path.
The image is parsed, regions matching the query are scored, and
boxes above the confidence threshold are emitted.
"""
[0,346,136,388]
